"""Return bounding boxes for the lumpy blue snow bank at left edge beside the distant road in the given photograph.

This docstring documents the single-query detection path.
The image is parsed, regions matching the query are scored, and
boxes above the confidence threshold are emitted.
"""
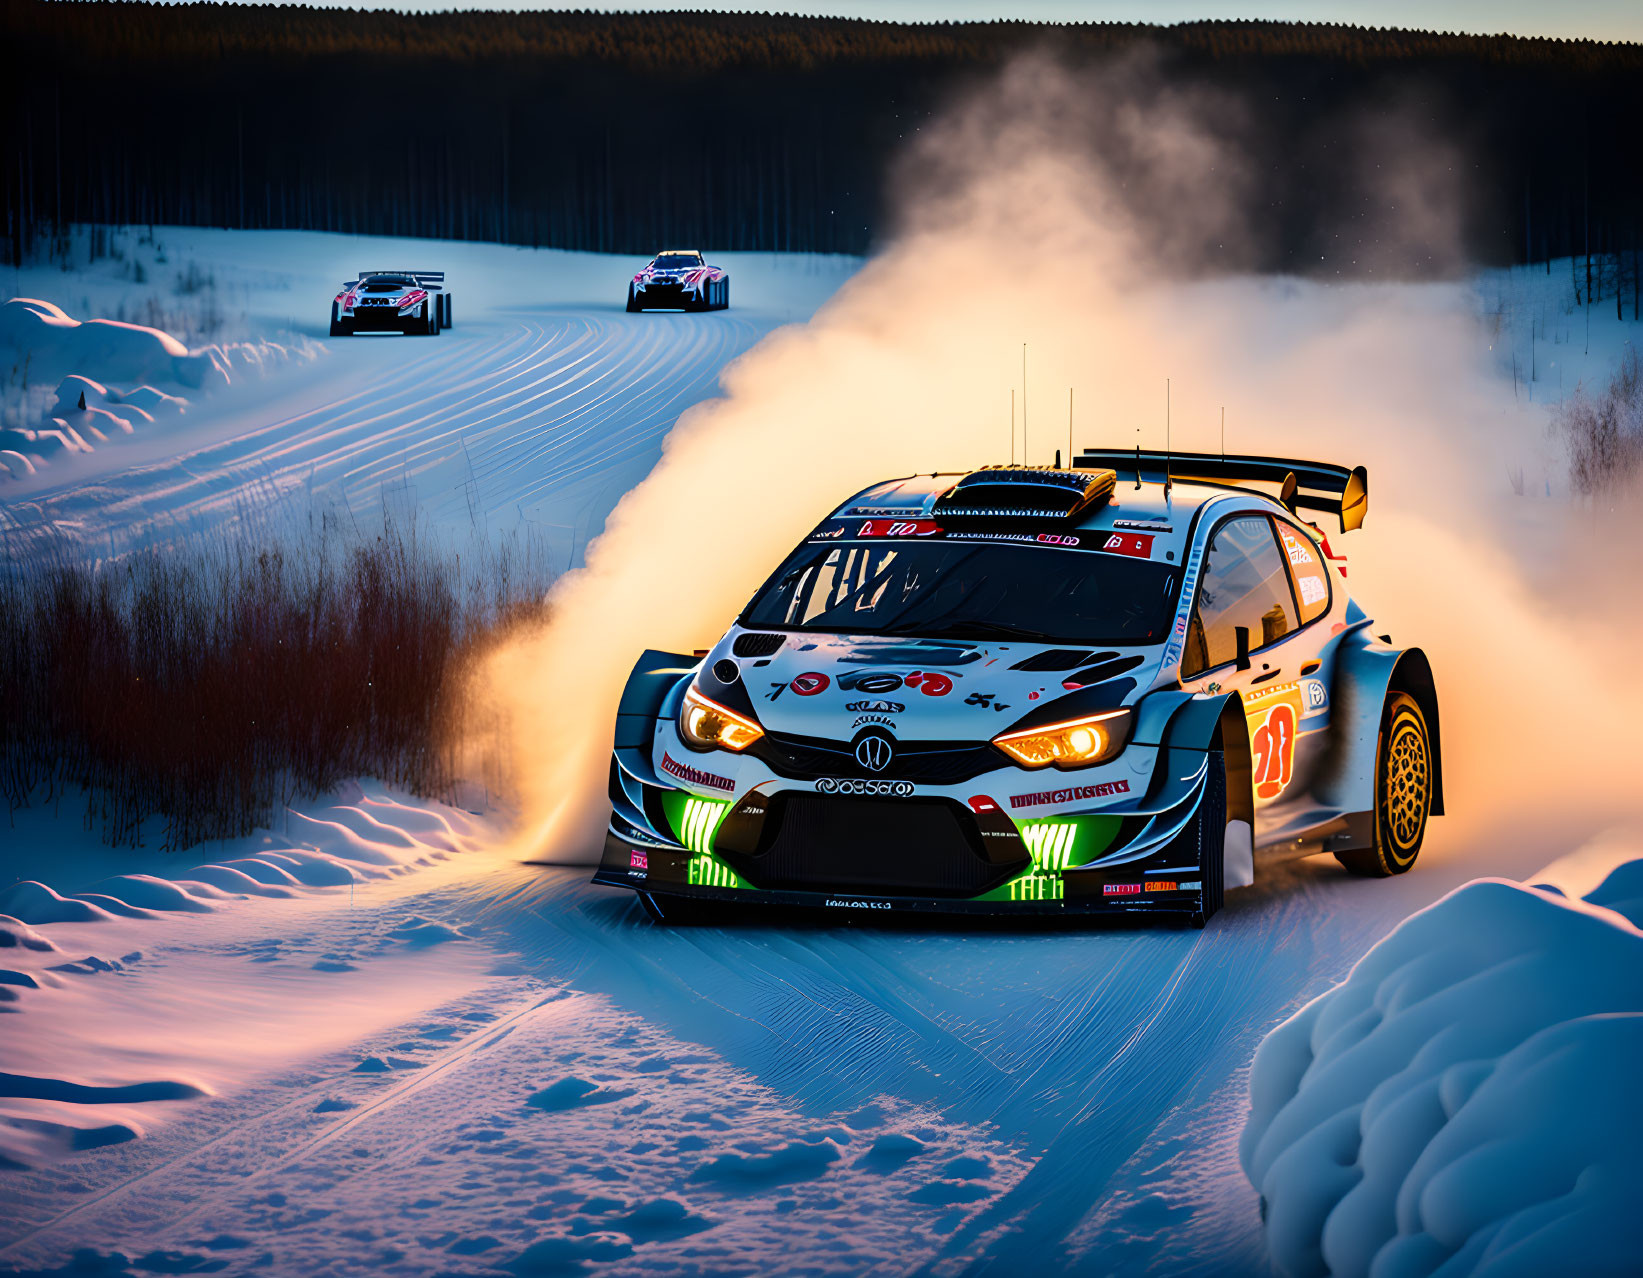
[0,297,312,478]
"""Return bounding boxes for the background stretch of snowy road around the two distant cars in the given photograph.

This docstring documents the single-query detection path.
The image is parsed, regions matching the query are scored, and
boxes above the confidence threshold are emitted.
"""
[0,232,858,568]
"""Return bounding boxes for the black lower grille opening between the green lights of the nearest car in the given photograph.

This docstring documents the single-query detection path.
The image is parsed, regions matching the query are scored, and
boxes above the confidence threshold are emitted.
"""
[720,793,1029,897]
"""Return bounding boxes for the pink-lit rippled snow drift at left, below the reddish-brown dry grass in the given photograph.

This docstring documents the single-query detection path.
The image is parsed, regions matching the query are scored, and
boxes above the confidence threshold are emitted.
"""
[0,782,488,1169]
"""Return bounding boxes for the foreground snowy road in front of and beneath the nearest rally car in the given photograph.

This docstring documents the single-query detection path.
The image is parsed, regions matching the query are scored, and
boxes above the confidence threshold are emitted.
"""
[0,800,1610,1275]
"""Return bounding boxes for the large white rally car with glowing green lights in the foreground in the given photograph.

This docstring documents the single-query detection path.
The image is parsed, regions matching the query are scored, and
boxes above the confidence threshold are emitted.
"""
[595,450,1443,926]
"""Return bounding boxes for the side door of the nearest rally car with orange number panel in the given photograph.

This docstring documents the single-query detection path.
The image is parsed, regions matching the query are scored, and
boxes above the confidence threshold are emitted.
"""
[1181,514,1328,846]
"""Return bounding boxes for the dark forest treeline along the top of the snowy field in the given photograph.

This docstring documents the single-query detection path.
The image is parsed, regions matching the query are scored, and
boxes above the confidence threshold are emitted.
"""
[0,0,1643,271]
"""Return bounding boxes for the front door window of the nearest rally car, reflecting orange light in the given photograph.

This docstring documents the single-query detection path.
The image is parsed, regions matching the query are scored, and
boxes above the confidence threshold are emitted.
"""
[1181,514,1296,678]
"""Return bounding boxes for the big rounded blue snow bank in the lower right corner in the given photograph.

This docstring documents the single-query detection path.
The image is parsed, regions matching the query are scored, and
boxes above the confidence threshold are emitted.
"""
[1239,861,1643,1278]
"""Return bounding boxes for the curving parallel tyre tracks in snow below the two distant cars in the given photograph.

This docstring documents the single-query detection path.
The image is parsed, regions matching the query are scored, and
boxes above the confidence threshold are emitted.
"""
[8,307,774,552]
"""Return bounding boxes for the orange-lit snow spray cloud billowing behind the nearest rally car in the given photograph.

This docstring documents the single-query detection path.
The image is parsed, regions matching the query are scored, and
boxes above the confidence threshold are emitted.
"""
[476,57,1636,861]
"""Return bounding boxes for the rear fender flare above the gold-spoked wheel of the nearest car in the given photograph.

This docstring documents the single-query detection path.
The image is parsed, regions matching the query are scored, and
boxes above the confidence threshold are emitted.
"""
[1314,634,1443,816]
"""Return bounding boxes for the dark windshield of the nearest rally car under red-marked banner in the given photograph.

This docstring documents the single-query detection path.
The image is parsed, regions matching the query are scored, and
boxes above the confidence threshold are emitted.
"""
[741,540,1178,644]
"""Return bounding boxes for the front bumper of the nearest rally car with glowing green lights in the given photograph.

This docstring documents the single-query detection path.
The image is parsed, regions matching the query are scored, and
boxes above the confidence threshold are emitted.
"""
[593,754,1226,920]
